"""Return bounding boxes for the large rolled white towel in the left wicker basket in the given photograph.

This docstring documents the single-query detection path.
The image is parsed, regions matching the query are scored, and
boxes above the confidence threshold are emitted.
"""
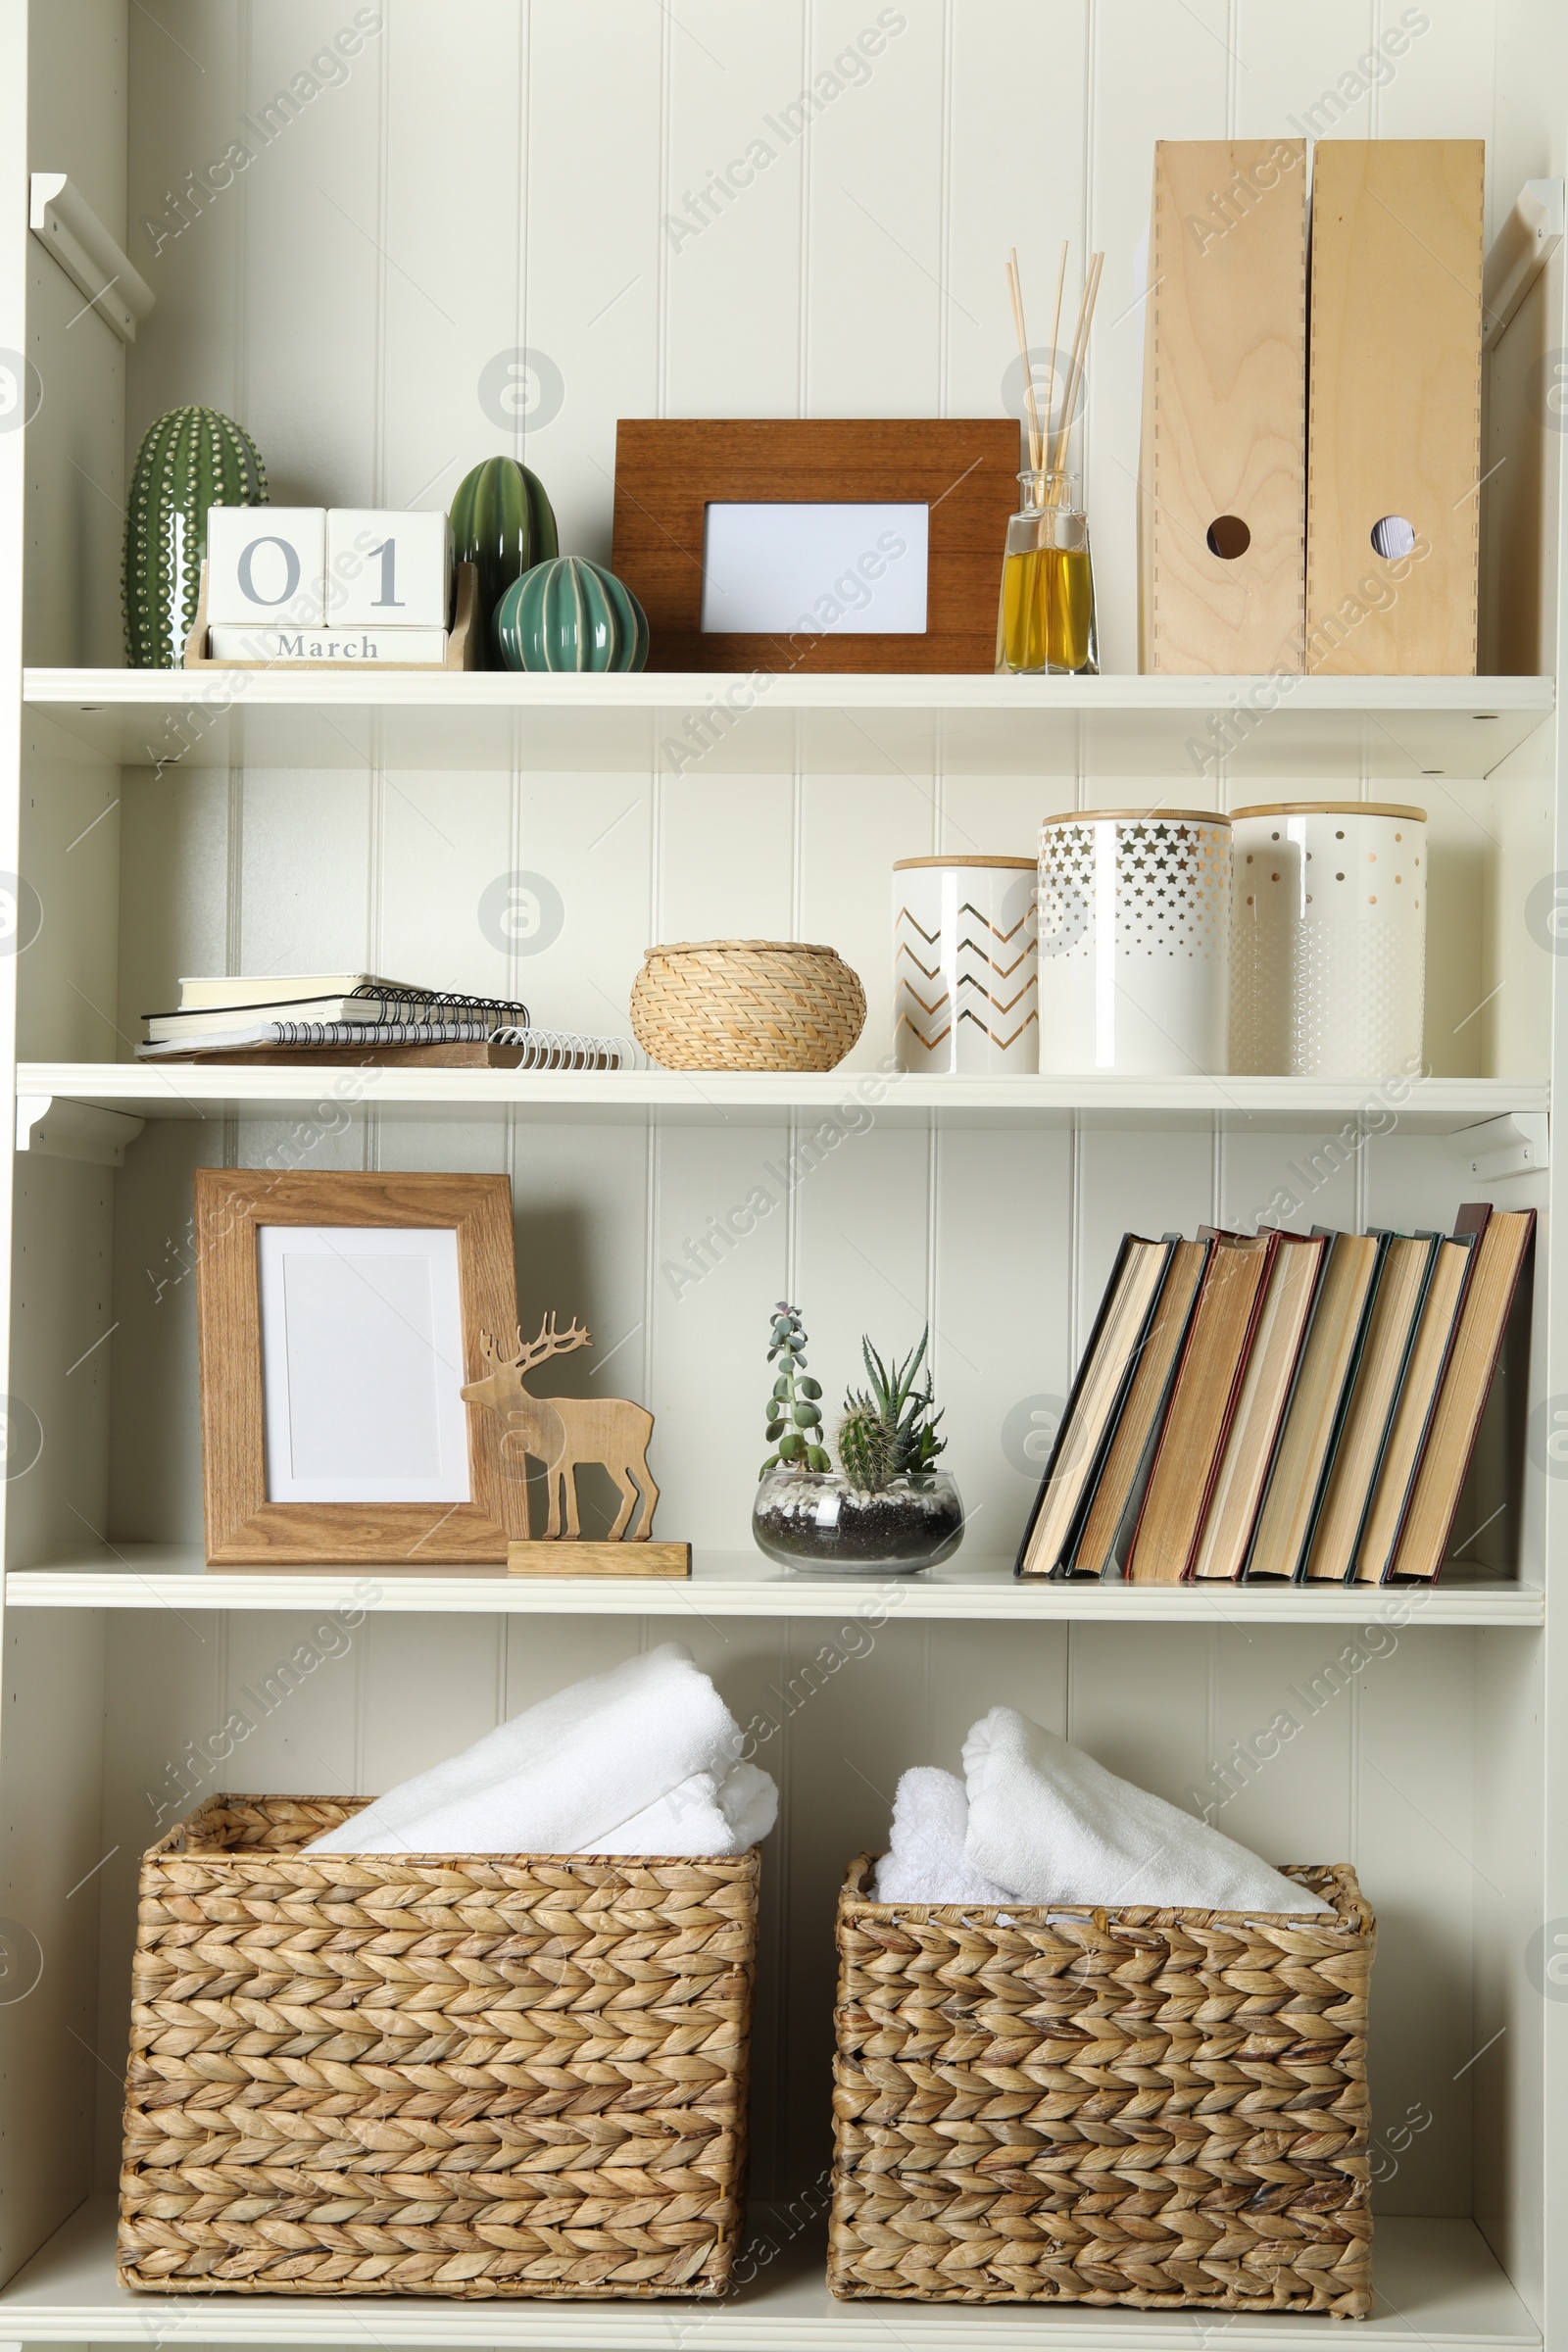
[311,1642,770,1853]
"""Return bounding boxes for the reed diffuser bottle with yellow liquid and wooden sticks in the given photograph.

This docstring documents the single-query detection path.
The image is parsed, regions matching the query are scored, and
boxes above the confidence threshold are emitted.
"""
[997,245,1104,677]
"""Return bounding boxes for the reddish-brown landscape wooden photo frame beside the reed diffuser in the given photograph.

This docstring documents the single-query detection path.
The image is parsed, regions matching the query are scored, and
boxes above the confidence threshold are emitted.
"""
[613,416,1020,672]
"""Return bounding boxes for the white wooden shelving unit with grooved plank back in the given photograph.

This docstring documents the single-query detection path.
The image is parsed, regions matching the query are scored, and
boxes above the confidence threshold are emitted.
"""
[0,0,1568,2352]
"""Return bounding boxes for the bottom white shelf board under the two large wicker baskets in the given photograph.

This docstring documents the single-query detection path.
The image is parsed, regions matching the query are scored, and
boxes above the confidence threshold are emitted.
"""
[0,2199,1540,2352]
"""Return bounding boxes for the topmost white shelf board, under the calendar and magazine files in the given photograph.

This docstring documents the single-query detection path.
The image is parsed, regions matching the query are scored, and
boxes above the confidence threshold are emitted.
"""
[24,670,1556,776]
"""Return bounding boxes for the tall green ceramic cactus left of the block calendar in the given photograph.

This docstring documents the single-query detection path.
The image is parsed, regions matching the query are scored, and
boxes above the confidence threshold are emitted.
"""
[122,410,268,670]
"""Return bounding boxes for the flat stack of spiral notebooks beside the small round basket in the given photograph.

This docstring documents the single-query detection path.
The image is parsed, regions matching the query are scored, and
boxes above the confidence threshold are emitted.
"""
[136,971,635,1070]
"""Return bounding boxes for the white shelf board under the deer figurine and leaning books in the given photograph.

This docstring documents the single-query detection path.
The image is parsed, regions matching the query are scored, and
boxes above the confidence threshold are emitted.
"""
[0,1543,1544,1618]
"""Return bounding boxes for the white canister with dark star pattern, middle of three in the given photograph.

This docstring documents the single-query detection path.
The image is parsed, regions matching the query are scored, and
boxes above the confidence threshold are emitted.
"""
[1039,809,1230,1077]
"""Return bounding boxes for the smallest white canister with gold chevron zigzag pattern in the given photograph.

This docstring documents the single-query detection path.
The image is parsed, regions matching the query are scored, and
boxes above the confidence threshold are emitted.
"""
[894,857,1039,1075]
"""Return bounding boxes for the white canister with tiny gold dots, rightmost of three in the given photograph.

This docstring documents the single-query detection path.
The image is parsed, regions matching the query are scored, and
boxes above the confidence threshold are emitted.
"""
[1230,800,1427,1077]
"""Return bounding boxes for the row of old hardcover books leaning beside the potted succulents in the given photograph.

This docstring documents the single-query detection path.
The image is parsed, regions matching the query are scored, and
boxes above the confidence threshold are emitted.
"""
[1018,1204,1535,1586]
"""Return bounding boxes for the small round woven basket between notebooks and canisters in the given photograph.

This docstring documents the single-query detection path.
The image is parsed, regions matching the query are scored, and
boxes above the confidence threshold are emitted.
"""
[632,939,865,1070]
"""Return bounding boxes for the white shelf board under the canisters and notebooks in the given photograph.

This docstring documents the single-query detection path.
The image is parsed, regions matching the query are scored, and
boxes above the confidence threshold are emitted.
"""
[17,1060,1549,1136]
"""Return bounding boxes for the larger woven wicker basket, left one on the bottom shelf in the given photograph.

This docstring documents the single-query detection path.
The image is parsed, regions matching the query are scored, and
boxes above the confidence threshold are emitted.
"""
[120,1797,757,2295]
